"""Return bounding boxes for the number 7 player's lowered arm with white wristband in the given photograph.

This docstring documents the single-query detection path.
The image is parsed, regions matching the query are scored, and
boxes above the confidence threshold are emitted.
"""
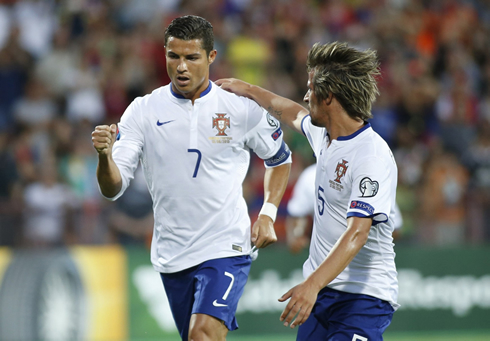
[252,163,291,249]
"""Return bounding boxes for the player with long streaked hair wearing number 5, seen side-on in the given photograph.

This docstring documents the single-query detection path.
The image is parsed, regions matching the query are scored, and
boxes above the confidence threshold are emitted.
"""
[216,42,398,341]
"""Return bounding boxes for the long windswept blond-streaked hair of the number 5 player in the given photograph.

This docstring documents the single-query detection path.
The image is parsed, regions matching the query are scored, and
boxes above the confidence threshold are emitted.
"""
[306,42,380,121]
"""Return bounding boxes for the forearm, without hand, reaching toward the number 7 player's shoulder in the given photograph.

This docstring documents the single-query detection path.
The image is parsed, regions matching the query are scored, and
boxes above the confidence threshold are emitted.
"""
[247,85,308,133]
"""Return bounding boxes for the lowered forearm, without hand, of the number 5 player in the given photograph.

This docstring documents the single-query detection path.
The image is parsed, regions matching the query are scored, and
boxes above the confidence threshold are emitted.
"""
[306,218,371,291]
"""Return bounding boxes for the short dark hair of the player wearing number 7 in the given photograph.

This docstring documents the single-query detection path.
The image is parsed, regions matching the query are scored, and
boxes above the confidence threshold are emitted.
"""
[165,15,214,56]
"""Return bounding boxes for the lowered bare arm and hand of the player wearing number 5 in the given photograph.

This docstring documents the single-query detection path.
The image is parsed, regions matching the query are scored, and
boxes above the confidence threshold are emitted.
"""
[279,217,372,328]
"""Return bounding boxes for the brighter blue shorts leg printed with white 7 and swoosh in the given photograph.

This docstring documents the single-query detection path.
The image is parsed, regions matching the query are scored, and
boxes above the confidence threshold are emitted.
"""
[192,256,251,330]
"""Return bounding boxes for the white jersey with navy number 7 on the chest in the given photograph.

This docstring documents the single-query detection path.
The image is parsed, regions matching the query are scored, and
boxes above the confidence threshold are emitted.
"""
[106,82,291,273]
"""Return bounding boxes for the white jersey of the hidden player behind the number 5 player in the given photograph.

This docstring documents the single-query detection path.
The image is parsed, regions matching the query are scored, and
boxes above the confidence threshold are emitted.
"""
[287,164,316,217]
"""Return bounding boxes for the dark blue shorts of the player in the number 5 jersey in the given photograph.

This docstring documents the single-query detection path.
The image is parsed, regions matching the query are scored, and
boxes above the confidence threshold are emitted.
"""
[296,288,395,341]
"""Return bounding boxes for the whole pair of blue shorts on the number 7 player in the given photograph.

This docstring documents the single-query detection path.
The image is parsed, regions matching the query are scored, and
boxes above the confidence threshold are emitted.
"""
[160,256,252,340]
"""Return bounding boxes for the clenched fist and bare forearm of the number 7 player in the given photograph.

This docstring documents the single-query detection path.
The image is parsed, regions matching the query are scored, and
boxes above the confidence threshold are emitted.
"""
[92,124,122,198]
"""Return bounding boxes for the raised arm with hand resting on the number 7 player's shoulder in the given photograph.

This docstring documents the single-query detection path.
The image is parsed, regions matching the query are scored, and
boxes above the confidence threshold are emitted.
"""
[215,78,308,134]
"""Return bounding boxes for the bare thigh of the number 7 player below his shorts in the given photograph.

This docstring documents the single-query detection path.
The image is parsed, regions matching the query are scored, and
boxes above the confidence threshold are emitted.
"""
[189,314,228,341]
